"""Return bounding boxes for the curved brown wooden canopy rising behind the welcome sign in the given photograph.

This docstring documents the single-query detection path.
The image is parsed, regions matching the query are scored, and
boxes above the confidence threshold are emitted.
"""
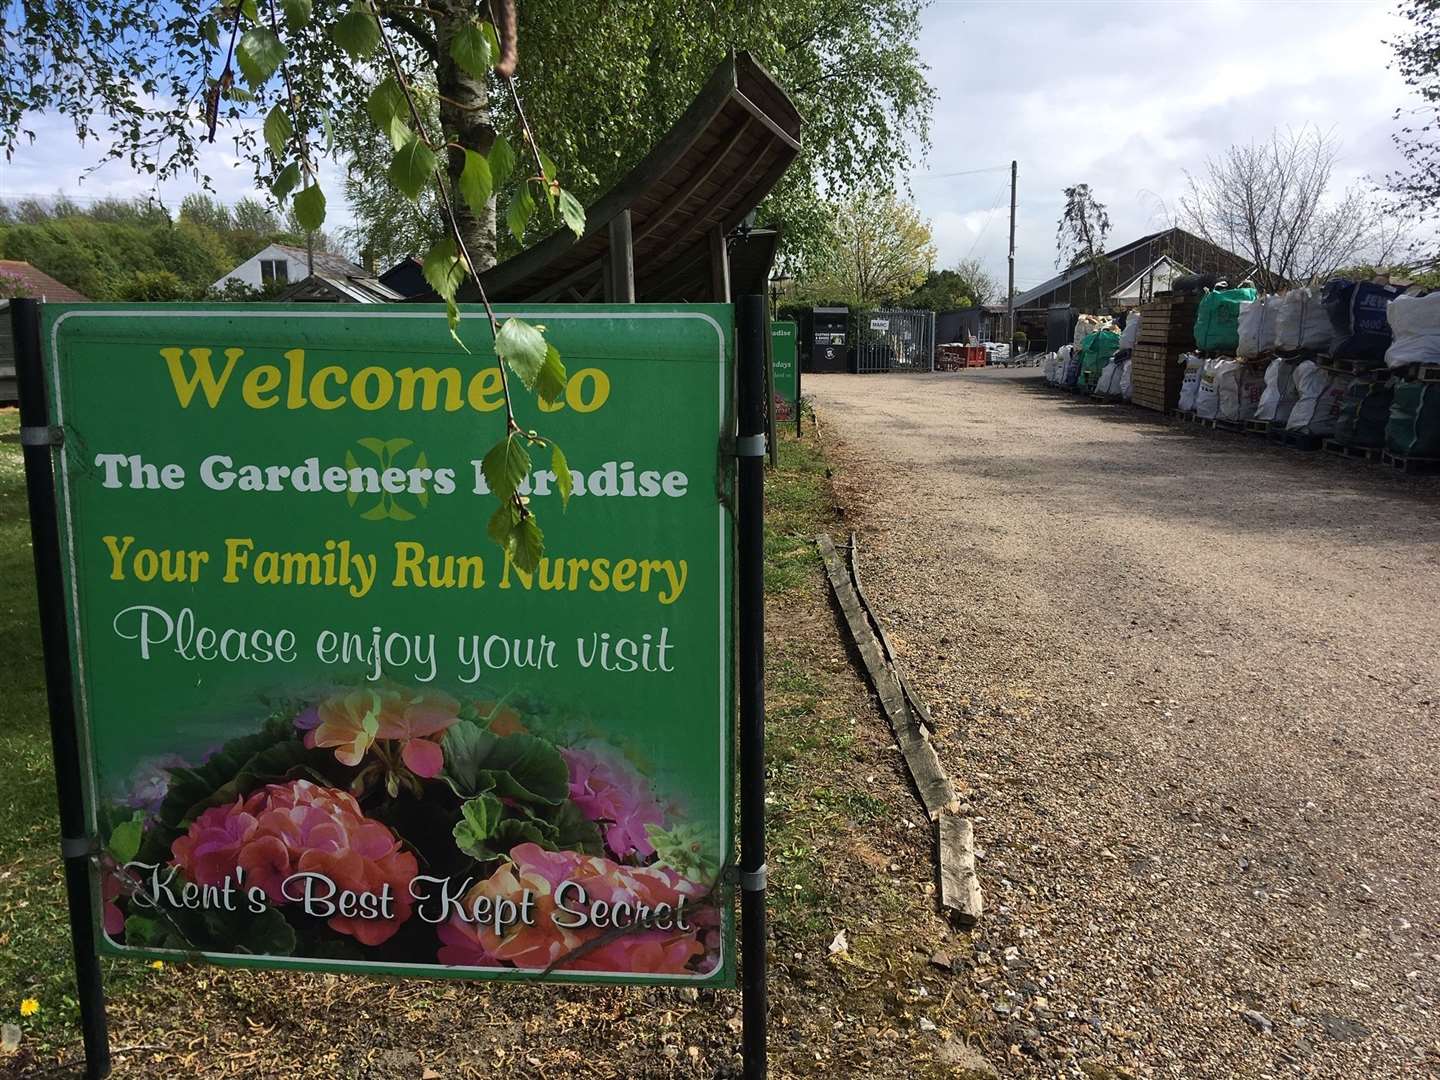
[461,52,802,302]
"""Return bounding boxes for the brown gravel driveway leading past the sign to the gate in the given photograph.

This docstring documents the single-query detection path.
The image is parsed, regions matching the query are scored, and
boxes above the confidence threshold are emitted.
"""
[805,370,1440,1080]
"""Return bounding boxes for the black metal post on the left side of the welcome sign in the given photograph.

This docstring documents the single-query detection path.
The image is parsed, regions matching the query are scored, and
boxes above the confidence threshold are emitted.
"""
[10,300,109,1080]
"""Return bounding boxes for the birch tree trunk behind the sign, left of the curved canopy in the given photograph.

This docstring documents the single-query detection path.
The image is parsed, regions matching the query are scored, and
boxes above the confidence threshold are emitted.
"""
[435,0,495,272]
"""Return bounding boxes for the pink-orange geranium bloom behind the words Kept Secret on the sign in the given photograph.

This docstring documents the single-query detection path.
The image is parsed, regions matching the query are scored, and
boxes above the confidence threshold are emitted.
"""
[439,844,706,975]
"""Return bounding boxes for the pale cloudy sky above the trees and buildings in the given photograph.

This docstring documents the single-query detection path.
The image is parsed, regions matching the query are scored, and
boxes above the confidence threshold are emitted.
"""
[0,0,1411,289]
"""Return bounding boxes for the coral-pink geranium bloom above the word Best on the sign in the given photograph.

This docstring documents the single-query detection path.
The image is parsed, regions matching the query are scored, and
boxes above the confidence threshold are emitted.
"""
[170,780,419,945]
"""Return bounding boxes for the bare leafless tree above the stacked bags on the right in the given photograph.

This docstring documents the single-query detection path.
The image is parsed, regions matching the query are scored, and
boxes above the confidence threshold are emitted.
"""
[1179,127,1382,292]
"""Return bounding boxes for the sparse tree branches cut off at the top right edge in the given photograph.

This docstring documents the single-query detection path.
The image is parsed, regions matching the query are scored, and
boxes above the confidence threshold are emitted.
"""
[1387,0,1440,240]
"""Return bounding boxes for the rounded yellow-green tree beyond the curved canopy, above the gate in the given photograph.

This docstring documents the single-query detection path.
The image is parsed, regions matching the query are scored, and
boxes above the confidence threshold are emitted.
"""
[799,192,935,308]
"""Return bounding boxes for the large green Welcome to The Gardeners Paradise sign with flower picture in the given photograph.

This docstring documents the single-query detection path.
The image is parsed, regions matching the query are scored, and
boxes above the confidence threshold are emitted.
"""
[43,304,733,985]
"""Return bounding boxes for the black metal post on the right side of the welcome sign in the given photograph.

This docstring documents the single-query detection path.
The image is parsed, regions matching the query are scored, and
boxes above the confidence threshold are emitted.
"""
[736,295,770,1080]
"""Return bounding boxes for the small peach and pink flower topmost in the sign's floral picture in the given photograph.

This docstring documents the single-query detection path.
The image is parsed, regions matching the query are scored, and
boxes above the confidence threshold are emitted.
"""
[295,687,459,779]
